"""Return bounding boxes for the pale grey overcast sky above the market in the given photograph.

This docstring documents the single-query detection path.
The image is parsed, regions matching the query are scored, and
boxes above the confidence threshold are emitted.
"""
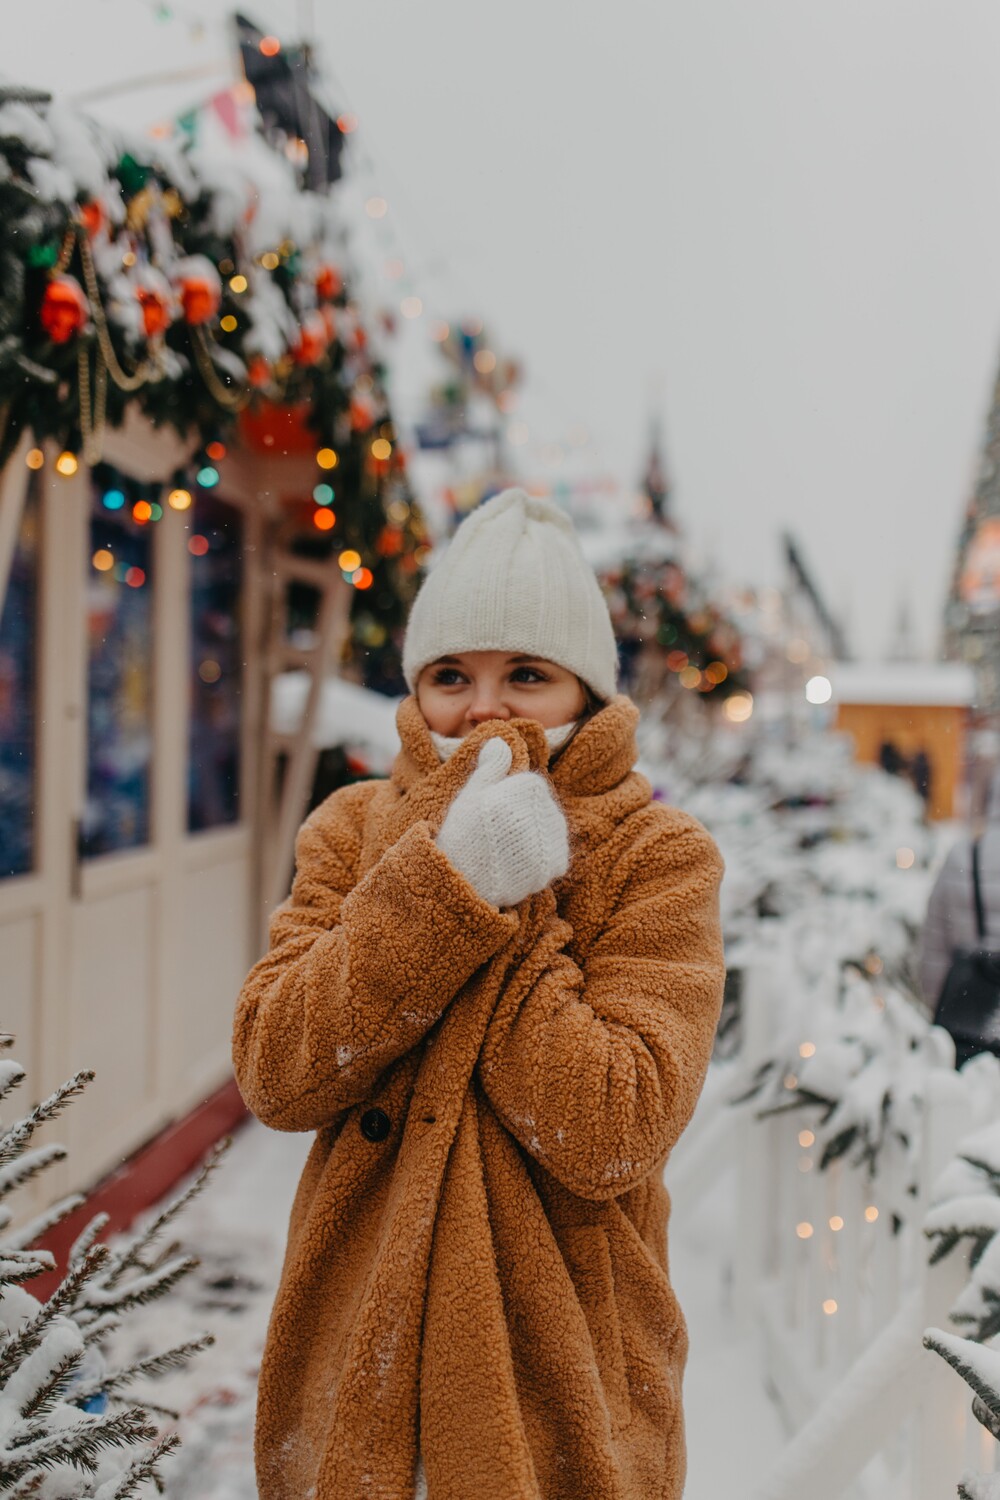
[7,0,1000,656]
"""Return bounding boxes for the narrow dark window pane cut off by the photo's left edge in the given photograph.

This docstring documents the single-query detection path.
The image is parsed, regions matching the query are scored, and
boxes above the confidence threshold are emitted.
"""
[0,473,40,879]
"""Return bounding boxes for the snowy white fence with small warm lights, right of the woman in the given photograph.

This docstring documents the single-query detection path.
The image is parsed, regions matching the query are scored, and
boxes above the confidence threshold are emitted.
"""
[667,966,1000,1500]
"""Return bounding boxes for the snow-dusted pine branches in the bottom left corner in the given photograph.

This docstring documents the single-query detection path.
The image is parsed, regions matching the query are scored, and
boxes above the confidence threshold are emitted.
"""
[0,1035,220,1500]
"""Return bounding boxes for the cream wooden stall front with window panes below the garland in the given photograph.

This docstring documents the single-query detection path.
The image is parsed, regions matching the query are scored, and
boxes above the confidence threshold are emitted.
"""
[0,423,253,1188]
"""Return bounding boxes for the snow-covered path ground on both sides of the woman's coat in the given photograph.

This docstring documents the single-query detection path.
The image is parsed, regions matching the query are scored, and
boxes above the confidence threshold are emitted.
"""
[127,1121,783,1500]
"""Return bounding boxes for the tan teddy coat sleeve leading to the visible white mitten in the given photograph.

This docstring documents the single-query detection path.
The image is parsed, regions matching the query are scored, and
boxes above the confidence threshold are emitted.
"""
[232,783,517,1131]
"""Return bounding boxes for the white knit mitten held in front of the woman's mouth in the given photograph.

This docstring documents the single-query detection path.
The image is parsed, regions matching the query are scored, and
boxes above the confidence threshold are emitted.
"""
[436,738,570,906]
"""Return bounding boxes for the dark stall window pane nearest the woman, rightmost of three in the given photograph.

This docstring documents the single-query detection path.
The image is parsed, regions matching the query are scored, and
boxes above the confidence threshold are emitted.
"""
[187,491,243,833]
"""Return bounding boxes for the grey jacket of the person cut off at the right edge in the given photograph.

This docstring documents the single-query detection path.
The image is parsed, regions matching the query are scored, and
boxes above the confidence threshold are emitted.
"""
[921,771,1000,1013]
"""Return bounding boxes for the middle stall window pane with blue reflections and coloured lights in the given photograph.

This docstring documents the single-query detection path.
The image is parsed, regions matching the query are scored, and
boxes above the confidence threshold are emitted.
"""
[81,467,154,858]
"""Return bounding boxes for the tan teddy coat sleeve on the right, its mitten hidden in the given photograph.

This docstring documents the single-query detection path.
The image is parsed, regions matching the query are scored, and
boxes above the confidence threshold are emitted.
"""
[480,813,724,1200]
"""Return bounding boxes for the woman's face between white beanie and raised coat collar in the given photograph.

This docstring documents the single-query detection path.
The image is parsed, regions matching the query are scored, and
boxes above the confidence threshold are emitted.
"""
[417,651,586,740]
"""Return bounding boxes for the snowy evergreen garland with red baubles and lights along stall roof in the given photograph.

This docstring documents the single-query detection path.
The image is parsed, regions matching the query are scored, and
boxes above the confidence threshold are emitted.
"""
[0,87,427,686]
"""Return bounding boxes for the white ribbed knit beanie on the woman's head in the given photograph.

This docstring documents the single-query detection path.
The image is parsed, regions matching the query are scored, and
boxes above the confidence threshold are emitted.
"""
[403,489,618,698]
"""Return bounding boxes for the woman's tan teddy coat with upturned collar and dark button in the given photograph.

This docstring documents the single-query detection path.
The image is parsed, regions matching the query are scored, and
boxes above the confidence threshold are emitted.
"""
[234,696,723,1500]
